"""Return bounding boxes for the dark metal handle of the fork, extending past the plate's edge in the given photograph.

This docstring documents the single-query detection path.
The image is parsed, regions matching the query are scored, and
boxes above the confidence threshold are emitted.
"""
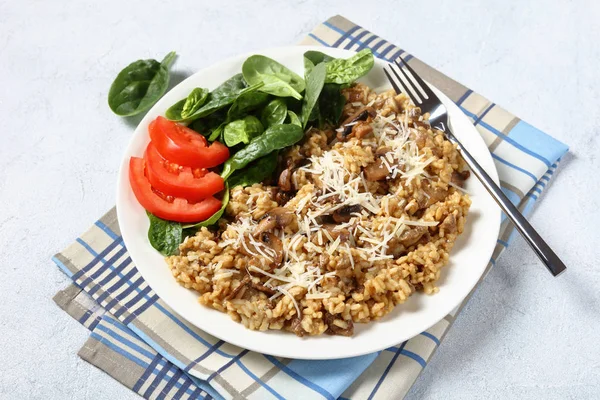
[445,128,567,276]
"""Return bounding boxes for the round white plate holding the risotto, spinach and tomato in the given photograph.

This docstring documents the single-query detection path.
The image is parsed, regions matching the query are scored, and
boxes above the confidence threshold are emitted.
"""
[117,46,500,359]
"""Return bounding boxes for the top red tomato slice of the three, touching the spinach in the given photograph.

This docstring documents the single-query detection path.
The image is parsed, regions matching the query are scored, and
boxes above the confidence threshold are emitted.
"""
[148,116,229,168]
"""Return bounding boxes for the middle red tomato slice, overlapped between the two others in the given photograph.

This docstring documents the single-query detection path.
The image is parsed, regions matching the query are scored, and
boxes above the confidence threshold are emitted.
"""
[144,142,225,203]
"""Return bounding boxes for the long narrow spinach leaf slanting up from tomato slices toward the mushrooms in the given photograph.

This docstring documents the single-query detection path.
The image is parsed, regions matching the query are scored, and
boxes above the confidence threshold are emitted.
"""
[221,124,304,179]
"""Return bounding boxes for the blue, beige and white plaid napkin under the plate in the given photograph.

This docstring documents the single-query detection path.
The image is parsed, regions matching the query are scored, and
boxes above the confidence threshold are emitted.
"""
[53,16,567,400]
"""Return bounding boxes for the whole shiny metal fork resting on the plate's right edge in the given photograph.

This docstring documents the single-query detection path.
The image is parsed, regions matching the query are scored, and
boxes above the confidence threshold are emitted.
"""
[383,58,567,276]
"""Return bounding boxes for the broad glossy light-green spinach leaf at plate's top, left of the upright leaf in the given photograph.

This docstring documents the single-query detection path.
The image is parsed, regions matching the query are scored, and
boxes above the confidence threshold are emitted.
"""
[242,55,304,99]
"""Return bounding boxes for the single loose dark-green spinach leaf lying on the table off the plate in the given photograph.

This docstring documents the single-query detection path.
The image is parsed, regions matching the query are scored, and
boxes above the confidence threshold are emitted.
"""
[108,51,175,117]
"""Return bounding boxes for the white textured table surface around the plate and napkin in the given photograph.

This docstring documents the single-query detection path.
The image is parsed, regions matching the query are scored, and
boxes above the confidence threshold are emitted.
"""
[0,0,600,399]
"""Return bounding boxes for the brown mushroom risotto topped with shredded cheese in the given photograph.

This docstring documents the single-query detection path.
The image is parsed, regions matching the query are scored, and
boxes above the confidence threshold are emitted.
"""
[166,84,471,336]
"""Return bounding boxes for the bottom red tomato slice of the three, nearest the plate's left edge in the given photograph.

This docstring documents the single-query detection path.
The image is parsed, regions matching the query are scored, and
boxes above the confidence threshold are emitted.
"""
[129,157,221,222]
